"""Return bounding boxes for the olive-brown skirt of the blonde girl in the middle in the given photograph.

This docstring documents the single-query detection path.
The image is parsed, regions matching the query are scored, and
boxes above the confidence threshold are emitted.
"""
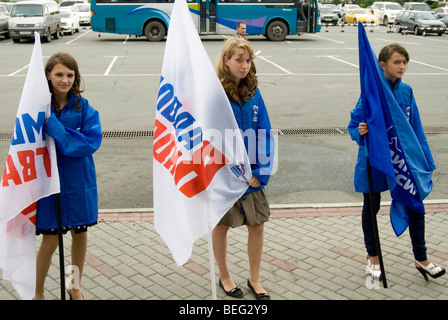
[218,189,270,228]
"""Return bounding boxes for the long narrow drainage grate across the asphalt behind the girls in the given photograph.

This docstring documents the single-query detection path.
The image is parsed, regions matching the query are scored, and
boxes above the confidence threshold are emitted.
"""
[0,126,448,140]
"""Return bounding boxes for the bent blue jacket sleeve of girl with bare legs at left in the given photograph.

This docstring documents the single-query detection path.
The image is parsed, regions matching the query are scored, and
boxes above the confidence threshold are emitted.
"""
[45,104,102,157]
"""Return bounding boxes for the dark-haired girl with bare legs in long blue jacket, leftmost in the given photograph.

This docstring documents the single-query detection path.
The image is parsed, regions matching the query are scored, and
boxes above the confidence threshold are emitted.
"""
[34,52,102,299]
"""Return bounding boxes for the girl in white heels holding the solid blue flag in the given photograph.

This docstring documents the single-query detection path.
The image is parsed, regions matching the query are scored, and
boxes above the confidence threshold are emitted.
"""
[348,44,445,280]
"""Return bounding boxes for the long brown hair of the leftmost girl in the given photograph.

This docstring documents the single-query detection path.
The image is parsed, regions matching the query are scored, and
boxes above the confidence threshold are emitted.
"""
[45,52,84,109]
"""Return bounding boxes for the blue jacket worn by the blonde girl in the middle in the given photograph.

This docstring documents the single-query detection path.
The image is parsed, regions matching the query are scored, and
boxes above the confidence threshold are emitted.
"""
[229,89,275,193]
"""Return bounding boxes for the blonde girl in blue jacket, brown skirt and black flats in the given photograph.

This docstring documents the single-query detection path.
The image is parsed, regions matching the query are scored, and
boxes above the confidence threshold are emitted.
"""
[212,37,274,300]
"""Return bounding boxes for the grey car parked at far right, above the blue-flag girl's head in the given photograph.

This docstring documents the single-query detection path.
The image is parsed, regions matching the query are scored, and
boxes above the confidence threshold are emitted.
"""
[395,10,446,36]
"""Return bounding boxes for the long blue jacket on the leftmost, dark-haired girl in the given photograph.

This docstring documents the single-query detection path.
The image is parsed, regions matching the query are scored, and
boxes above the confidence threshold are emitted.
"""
[36,95,102,230]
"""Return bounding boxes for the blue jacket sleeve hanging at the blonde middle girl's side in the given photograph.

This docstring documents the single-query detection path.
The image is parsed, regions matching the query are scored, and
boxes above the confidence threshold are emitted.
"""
[251,94,275,186]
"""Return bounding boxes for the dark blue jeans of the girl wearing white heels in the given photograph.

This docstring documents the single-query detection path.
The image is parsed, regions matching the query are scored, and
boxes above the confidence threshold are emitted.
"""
[362,192,427,261]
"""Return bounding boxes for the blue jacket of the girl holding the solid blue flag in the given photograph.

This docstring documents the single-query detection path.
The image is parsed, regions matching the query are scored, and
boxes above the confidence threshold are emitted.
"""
[348,79,436,193]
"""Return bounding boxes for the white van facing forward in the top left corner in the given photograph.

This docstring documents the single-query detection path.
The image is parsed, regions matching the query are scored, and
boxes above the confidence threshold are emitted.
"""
[8,0,61,42]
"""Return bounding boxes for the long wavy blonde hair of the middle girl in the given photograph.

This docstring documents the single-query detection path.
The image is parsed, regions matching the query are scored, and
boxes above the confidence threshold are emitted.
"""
[216,37,258,102]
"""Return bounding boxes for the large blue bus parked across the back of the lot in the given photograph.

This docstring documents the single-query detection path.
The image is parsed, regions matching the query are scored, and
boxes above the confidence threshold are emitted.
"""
[90,0,321,41]
